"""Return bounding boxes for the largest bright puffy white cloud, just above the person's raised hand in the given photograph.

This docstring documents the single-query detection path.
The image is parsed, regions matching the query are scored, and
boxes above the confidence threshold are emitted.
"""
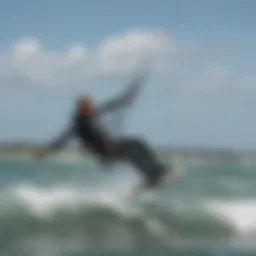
[97,31,174,73]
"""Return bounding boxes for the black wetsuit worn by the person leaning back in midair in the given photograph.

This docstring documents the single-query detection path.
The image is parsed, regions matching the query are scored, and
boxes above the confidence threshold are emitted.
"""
[50,83,167,186]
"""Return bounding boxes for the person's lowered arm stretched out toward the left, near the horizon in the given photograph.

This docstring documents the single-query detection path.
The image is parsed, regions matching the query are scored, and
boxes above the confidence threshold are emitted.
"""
[34,127,74,158]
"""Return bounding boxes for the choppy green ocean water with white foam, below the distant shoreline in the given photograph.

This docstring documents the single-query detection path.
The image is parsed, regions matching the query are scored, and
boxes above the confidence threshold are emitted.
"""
[0,155,256,256]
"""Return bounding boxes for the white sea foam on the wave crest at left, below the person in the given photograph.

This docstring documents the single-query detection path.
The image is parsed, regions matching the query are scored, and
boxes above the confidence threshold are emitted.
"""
[6,174,142,217]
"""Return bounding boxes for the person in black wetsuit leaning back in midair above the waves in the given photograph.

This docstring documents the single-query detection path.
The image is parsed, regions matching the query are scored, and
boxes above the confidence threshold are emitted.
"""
[35,73,176,188]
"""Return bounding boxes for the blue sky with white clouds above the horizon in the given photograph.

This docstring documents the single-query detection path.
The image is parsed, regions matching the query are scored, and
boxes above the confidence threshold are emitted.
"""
[0,0,256,149]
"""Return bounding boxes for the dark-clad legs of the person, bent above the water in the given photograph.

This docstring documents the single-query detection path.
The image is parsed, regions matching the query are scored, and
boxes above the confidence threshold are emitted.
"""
[116,138,167,187]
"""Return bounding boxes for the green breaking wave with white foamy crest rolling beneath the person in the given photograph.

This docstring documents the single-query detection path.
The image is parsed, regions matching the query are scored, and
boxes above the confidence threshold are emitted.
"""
[0,185,240,250]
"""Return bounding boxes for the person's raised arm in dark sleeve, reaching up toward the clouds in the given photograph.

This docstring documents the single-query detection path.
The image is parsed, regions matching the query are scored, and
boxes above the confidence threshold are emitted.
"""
[96,71,149,116]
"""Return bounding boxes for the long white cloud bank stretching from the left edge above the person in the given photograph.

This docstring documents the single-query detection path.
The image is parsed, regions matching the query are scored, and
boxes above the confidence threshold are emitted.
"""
[0,31,174,86]
